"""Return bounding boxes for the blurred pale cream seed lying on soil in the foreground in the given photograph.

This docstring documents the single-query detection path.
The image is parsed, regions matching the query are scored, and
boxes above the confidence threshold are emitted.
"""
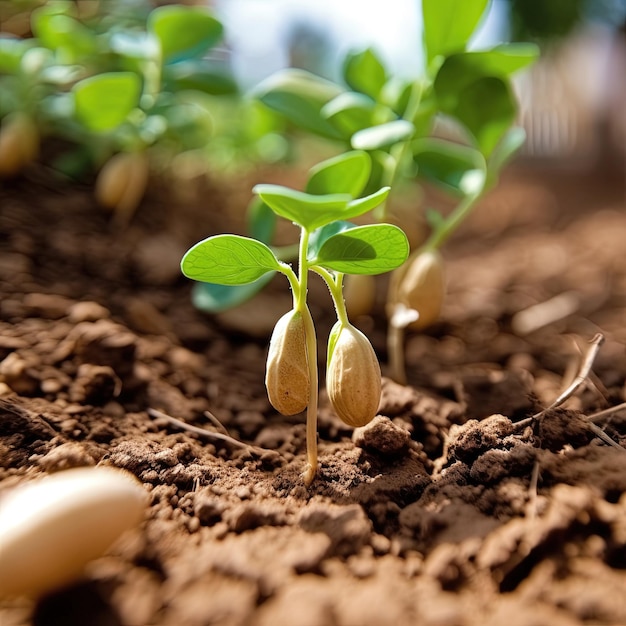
[0,467,148,597]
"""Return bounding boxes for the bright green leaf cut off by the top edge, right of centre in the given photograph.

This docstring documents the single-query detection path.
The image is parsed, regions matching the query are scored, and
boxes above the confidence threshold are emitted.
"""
[422,0,489,63]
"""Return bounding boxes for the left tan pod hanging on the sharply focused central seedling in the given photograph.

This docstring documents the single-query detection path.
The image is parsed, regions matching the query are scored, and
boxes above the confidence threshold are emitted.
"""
[265,310,311,415]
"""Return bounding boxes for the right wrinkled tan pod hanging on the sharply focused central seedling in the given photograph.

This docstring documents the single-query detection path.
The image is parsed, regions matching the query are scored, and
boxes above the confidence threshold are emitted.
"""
[326,322,381,428]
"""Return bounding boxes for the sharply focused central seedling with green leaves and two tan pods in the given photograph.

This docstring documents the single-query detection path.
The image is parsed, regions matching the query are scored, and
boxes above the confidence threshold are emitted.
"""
[181,150,409,485]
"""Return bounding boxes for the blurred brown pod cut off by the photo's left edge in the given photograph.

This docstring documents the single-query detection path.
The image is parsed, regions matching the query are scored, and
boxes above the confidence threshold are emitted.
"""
[0,113,39,178]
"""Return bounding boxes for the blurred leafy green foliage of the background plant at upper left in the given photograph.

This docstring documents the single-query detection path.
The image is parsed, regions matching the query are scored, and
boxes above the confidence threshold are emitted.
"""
[0,0,260,219]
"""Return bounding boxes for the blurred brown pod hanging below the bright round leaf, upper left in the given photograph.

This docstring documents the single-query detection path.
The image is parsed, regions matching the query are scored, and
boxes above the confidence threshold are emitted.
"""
[95,152,150,223]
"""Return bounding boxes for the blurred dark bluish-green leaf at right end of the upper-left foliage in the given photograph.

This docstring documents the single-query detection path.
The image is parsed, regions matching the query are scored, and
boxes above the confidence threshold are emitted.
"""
[163,59,238,96]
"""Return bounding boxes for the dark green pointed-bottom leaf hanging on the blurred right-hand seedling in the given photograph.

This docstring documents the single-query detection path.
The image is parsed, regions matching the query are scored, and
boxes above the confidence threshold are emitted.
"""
[453,78,517,156]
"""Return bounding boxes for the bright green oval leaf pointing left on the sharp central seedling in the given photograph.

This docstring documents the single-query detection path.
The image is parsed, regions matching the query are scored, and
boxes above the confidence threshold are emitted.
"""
[181,235,280,285]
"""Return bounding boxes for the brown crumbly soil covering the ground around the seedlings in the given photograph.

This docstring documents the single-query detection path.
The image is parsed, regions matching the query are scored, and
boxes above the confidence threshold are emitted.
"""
[0,155,626,626]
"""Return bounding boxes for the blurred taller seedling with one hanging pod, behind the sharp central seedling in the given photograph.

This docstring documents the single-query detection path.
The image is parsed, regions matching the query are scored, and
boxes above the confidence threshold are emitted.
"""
[255,0,538,382]
